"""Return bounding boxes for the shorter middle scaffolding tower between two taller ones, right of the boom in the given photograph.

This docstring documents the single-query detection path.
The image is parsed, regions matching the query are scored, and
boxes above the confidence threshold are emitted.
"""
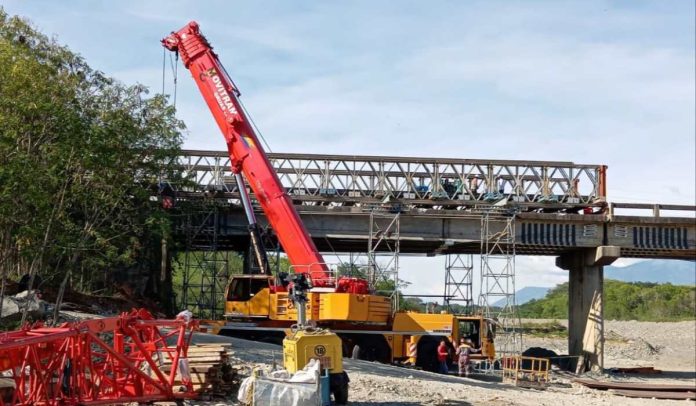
[443,254,474,314]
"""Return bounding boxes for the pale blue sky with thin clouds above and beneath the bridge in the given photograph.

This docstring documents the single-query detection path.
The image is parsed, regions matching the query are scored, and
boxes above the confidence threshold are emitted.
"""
[2,0,696,292]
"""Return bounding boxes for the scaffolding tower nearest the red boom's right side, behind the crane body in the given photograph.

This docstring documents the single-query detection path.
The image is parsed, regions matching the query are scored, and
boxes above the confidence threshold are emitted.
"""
[366,209,401,311]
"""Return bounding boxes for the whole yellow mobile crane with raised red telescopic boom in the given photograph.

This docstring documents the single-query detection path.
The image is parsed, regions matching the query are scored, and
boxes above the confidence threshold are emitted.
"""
[162,22,494,378]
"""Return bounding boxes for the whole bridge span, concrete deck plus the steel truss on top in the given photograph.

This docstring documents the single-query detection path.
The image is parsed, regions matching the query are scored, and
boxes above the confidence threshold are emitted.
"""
[163,150,696,259]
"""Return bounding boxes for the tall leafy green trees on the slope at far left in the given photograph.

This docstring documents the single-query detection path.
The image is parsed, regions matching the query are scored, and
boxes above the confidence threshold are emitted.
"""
[0,8,184,302]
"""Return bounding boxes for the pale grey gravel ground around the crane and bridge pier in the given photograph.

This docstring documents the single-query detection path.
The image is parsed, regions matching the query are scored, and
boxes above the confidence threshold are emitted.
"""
[186,321,696,406]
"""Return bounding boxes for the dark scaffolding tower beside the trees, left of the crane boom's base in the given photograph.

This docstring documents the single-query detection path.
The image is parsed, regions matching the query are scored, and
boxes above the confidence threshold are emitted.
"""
[179,205,230,319]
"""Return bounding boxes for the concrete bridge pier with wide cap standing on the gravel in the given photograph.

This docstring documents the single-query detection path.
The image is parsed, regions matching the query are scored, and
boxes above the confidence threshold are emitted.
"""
[556,246,621,369]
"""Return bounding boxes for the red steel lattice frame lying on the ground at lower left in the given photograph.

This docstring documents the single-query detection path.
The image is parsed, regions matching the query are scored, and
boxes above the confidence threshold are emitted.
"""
[0,309,197,405]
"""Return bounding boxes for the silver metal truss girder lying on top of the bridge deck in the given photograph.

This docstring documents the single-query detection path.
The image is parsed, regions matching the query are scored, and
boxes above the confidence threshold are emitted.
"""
[167,150,606,211]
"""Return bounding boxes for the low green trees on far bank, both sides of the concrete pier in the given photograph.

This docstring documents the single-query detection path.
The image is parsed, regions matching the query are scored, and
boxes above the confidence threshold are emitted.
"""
[519,279,696,321]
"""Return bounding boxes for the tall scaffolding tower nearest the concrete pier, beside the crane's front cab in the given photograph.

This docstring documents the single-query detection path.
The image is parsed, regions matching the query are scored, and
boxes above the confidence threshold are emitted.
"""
[479,207,522,357]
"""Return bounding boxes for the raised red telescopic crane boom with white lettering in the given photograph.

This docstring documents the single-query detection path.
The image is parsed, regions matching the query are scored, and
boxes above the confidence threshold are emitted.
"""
[162,21,367,293]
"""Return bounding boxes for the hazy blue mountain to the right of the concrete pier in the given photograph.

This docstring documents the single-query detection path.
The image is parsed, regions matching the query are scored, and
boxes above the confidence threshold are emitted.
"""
[604,259,696,285]
